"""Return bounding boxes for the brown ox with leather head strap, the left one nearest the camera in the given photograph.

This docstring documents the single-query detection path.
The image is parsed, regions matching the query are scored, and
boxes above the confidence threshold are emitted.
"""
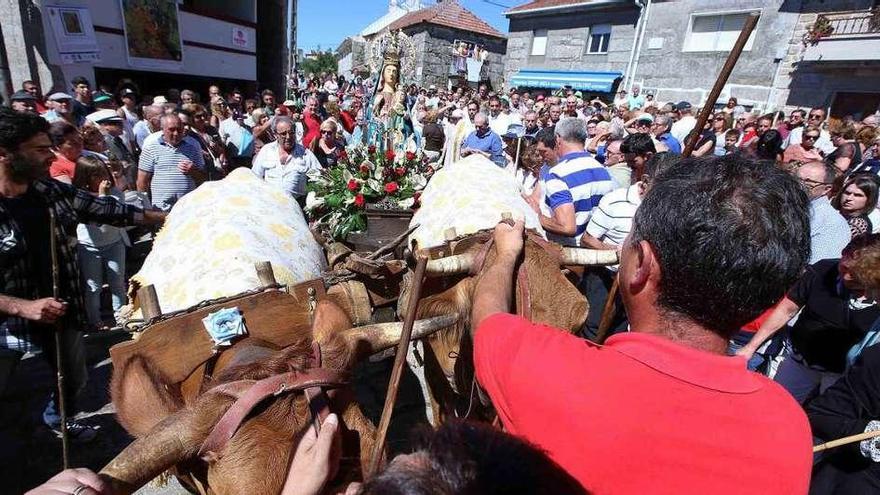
[101,294,454,494]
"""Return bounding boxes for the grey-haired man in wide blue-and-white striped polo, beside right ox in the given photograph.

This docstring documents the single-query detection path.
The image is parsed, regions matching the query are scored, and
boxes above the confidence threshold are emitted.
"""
[531,117,614,246]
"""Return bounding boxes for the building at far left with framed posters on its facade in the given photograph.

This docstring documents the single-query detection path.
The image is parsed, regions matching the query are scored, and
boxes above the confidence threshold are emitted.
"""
[0,0,296,101]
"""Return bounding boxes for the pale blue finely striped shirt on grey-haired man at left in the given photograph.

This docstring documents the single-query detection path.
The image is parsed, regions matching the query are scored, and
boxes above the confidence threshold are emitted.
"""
[138,136,205,211]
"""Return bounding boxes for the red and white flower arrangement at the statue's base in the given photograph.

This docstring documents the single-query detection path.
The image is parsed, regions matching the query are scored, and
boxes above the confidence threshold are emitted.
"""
[305,145,434,240]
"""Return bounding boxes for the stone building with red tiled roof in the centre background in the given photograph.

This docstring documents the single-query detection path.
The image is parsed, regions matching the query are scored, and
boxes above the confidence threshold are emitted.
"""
[387,0,506,88]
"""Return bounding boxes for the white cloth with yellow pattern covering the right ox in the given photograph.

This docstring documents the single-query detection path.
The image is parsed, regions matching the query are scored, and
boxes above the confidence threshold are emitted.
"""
[409,155,546,249]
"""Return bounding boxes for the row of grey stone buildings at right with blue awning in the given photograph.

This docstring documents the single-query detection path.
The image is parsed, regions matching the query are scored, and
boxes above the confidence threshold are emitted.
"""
[505,0,880,117]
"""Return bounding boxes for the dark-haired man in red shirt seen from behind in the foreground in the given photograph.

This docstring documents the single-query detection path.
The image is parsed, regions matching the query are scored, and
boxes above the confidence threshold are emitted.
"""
[472,156,812,494]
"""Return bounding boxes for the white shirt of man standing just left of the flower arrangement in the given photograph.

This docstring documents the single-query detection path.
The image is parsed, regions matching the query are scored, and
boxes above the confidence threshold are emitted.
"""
[251,141,321,198]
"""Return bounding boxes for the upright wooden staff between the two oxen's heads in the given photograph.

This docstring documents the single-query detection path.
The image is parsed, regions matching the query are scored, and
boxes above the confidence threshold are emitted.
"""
[367,254,428,479]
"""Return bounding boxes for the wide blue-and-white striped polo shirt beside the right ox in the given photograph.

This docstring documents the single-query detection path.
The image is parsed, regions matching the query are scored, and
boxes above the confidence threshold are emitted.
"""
[544,151,614,246]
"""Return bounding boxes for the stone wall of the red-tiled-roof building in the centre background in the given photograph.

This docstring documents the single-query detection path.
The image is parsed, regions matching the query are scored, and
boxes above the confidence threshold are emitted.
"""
[407,25,506,88]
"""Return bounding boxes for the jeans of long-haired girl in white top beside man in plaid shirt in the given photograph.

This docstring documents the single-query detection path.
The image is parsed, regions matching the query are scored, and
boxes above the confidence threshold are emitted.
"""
[78,240,126,327]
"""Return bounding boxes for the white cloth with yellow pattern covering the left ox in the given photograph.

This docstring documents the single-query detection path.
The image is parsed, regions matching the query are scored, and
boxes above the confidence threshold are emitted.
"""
[132,168,326,317]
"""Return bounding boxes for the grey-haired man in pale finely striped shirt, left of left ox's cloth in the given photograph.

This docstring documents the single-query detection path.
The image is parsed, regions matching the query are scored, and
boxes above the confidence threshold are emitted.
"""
[137,114,207,211]
